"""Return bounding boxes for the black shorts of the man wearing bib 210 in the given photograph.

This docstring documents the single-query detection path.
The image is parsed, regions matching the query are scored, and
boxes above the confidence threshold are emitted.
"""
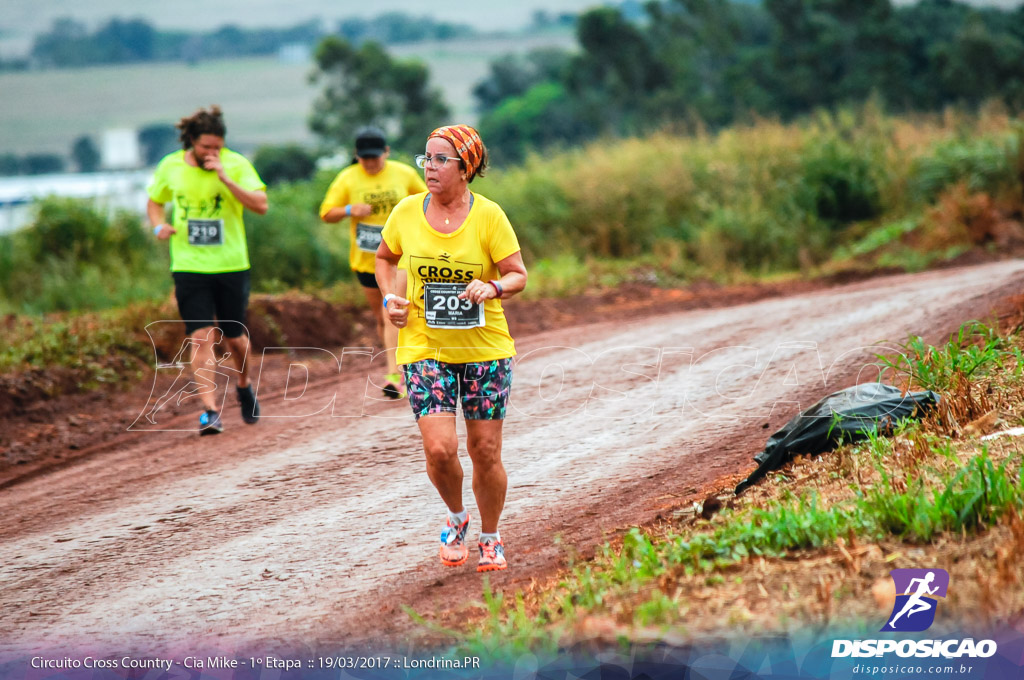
[171,269,249,338]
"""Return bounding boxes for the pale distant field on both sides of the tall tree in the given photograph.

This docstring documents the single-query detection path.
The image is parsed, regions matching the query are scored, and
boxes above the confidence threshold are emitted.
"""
[0,34,572,155]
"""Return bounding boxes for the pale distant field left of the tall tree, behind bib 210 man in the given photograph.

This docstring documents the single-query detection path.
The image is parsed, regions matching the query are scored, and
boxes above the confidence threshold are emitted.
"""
[0,58,315,154]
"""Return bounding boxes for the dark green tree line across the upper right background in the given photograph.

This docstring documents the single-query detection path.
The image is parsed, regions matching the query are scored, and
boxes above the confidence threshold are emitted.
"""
[475,0,1024,160]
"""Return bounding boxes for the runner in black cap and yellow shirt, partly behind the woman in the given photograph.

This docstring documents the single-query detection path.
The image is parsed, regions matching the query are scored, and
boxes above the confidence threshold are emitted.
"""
[319,126,427,398]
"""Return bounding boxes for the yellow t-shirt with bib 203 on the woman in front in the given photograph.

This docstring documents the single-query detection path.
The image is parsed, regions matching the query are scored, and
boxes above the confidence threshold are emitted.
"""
[383,189,519,364]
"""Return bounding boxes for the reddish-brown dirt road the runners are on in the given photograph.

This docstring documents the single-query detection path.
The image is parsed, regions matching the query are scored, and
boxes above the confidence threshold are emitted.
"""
[6,261,1024,656]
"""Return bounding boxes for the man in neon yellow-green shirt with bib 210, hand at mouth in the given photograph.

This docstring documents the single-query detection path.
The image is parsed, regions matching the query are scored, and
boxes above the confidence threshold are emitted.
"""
[146,107,267,434]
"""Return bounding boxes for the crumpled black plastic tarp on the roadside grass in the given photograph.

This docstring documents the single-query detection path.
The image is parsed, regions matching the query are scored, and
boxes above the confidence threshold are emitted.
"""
[736,383,941,494]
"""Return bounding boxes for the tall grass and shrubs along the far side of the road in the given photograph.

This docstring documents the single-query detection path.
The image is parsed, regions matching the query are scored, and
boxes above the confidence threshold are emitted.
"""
[8,103,1024,313]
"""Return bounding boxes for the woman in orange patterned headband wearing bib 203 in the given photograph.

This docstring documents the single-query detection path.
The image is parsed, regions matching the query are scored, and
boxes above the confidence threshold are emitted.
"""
[377,125,526,571]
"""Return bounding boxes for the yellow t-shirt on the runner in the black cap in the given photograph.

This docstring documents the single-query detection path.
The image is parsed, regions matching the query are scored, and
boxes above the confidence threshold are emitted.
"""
[321,161,427,273]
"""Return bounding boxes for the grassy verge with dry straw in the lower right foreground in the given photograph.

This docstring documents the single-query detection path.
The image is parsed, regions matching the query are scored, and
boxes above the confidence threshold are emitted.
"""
[436,324,1024,658]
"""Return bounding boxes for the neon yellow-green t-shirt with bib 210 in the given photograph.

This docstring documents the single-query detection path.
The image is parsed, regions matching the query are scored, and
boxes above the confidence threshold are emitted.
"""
[146,148,266,273]
